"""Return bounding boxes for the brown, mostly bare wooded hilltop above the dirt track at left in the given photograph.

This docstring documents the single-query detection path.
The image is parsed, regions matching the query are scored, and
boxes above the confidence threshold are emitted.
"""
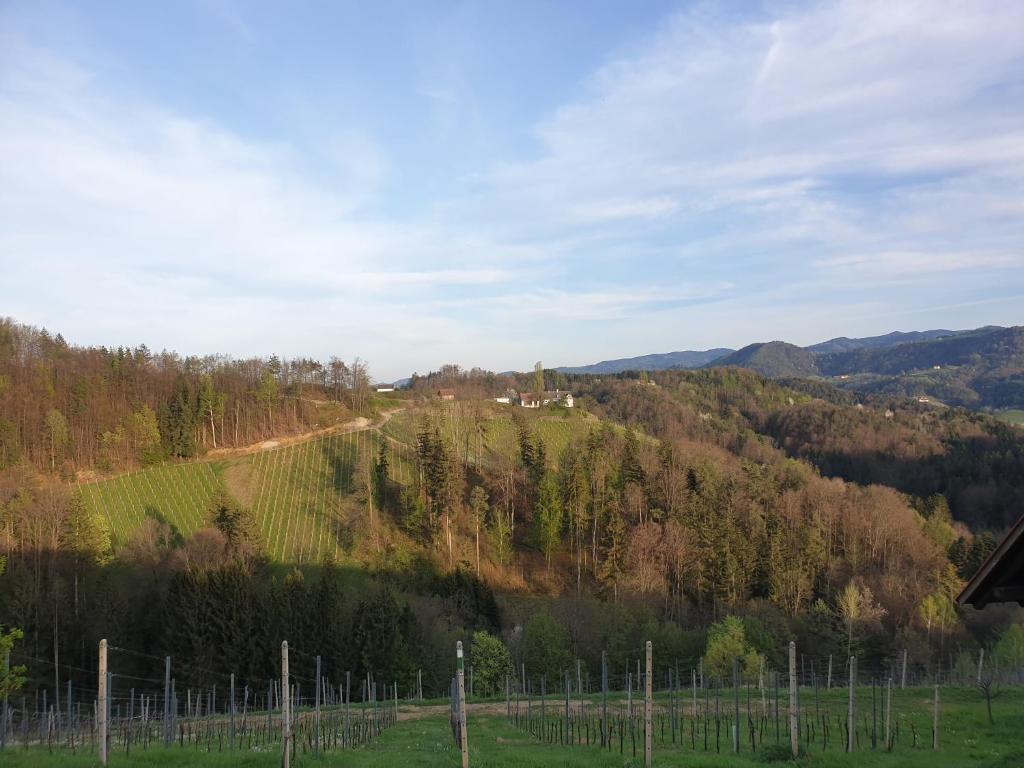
[0,317,373,477]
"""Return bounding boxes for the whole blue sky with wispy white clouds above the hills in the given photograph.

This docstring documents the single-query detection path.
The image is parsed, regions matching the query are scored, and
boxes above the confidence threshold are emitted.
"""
[0,0,1024,381]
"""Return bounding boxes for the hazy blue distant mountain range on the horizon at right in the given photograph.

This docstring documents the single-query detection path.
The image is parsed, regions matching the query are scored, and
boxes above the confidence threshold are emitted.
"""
[556,326,1024,410]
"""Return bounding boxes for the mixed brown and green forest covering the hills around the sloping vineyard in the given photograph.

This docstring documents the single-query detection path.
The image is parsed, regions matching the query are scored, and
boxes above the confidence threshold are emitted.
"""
[0,324,1024,712]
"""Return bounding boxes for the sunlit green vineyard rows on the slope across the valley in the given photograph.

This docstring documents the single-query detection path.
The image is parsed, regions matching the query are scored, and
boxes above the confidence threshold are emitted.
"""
[79,408,597,563]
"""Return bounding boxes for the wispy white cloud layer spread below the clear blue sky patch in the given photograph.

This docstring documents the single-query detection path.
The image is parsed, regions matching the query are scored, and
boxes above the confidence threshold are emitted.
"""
[0,0,1024,376]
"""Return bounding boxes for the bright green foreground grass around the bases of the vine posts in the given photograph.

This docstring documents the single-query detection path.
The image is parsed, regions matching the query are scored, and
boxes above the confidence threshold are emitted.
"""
[8,688,1024,768]
